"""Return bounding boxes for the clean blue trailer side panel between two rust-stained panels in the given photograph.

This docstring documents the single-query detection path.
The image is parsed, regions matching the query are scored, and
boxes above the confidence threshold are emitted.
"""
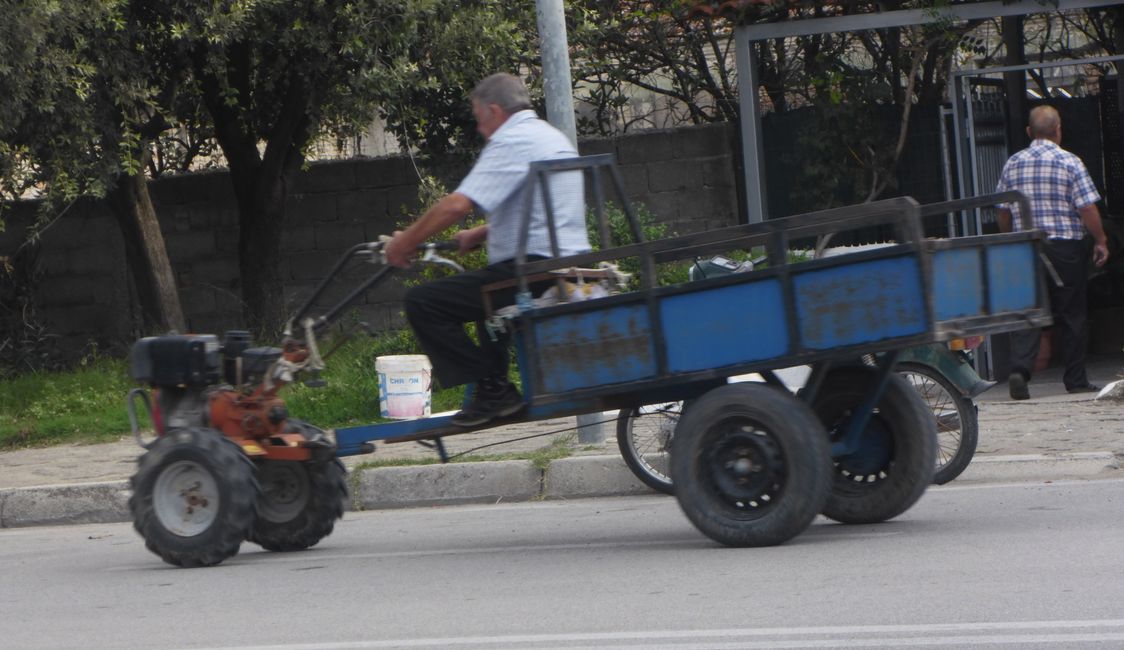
[660,278,789,372]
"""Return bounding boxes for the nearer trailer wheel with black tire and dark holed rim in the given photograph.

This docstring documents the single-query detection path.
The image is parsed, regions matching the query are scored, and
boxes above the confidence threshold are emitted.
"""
[671,383,831,547]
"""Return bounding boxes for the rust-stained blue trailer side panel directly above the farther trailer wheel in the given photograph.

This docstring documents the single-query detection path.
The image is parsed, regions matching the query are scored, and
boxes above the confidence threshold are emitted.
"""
[792,256,931,350]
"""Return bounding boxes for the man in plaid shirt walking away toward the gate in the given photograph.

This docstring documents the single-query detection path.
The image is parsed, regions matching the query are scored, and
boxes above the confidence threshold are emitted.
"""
[996,106,1108,399]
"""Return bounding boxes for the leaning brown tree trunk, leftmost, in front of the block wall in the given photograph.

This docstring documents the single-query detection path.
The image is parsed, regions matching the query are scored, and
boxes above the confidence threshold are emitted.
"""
[109,155,187,333]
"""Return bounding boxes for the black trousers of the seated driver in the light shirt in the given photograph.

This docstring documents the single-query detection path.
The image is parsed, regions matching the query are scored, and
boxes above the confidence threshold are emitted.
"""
[406,255,550,388]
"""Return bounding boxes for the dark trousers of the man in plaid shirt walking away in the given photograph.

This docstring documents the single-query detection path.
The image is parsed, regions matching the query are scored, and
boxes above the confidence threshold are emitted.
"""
[1010,240,1089,388]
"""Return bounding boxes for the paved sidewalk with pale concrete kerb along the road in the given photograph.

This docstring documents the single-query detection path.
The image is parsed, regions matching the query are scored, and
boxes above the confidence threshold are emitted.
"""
[0,355,1124,527]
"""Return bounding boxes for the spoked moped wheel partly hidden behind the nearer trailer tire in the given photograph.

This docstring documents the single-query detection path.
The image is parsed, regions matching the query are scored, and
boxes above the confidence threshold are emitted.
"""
[617,401,685,495]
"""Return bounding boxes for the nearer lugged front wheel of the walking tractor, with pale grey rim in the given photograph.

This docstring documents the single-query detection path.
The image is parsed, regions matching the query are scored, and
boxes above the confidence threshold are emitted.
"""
[129,427,259,567]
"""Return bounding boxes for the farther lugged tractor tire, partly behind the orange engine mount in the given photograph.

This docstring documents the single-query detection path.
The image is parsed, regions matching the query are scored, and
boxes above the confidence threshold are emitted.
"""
[246,421,347,552]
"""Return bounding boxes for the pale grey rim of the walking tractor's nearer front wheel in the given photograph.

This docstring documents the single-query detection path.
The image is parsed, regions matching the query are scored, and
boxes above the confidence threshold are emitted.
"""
[153,460,221,538]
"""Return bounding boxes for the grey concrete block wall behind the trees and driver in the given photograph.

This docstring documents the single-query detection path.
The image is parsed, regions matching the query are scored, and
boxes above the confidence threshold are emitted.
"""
[0,125,738,351]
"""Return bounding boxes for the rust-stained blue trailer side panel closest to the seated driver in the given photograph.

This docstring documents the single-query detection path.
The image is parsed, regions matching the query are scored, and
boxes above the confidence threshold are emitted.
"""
[534,305,655,394]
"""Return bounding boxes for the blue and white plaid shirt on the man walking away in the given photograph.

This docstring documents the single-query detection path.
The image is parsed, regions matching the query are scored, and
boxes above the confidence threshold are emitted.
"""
[996,139,1100,240]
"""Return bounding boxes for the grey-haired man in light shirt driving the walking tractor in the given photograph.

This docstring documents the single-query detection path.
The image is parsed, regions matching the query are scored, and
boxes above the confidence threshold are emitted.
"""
[386,73,590,426]
